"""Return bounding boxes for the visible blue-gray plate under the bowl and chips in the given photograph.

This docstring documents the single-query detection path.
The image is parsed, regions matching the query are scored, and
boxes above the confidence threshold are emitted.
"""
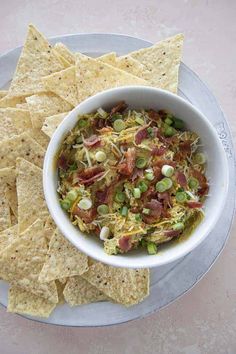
[0,34,235,326]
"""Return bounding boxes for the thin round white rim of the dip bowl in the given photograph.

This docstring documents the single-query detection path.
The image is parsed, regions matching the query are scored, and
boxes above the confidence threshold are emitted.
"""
[43,85,229,268]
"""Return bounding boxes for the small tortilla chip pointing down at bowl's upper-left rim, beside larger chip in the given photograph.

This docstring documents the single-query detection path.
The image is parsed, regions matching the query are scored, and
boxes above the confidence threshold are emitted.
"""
[42,66,78,107]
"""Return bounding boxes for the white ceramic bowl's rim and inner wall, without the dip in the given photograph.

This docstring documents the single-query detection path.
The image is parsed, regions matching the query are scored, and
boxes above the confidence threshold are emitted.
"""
[43,86,229,268]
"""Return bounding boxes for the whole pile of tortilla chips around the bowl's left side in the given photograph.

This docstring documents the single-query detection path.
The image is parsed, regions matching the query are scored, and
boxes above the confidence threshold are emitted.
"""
[0,25,183,317]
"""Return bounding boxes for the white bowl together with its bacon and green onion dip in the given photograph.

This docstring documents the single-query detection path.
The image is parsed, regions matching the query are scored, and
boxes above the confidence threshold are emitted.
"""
[44,87,228,268]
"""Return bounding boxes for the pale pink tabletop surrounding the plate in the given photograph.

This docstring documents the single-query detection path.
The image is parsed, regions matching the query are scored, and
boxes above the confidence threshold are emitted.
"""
[0,0,236,354]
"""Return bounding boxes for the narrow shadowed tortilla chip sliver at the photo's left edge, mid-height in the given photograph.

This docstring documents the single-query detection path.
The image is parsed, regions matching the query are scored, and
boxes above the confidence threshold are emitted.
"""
[0,167,17,218]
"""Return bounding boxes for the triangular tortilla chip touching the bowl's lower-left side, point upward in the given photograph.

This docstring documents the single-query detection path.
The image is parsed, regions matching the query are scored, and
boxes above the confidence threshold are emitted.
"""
[39,229,88,282]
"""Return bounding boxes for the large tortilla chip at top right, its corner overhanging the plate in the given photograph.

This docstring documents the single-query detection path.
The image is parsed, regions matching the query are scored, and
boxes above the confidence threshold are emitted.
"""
[128,34,184,93]
